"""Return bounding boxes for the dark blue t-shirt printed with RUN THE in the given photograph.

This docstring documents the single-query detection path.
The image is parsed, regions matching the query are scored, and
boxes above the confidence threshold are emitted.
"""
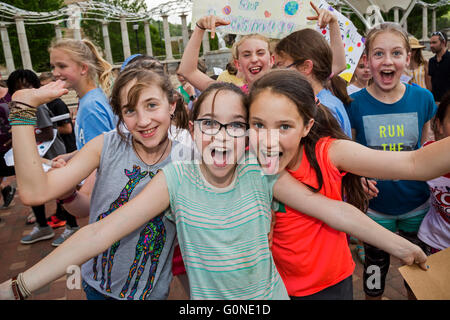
[348,84,436,215]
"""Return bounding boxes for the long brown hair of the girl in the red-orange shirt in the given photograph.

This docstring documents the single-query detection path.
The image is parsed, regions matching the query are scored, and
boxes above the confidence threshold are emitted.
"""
[249,69,368,211]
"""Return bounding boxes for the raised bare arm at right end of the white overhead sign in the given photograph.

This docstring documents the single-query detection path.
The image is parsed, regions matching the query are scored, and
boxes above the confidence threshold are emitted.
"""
[307,2,347,74]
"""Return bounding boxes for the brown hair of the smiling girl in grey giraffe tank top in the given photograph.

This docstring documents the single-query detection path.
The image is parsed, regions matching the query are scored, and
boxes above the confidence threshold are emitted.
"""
[110,68,188,140]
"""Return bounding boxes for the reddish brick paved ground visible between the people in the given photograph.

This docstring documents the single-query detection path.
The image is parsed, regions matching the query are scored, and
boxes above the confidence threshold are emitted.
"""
[0,178,406,300]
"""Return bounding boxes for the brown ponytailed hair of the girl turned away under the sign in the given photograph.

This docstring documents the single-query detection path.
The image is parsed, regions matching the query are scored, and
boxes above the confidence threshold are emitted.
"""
[275,29,352,104]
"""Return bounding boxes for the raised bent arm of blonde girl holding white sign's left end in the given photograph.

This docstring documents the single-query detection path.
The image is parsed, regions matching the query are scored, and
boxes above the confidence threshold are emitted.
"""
[178,16,229,91]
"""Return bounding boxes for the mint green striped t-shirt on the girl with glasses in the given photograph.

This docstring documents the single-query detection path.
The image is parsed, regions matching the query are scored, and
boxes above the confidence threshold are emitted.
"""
[163,156,289,299]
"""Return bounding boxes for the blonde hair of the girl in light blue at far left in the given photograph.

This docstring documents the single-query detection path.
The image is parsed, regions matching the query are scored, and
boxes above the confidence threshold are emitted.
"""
[49,39,113,95]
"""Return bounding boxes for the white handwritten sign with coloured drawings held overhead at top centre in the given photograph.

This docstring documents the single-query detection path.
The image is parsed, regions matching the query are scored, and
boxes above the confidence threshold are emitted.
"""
[192,0,319,39]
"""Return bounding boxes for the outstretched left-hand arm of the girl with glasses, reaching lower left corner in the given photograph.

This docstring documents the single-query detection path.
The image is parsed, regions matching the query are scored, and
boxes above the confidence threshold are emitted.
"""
[0,172,169,300]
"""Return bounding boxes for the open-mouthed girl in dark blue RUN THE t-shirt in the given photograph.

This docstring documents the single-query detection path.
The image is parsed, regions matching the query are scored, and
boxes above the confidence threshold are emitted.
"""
[348,23,436,299]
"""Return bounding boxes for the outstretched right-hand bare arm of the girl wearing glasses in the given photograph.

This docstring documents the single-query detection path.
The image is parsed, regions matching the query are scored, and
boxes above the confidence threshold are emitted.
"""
[273,171,427,270]
